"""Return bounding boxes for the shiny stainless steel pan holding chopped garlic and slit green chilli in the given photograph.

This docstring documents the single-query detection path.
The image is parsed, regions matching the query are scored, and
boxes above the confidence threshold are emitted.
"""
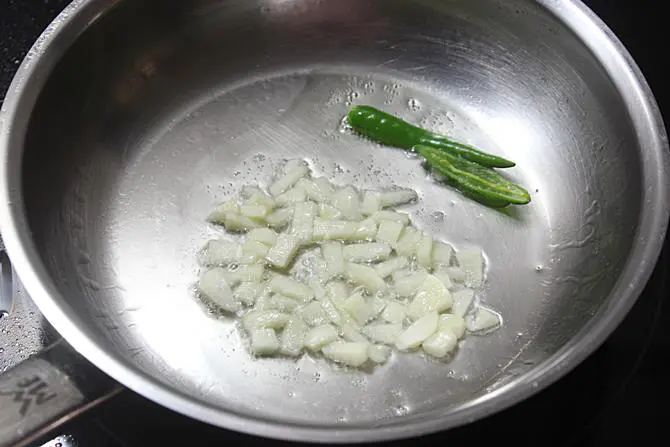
[0,0,670,442]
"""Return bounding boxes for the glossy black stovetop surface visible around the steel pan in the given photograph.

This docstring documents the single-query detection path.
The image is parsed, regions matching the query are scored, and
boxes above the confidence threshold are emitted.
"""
[0,0,670,447]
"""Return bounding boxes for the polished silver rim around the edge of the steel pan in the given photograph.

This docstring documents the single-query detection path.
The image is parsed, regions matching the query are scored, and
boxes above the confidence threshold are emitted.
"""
[0,0,670,443]
